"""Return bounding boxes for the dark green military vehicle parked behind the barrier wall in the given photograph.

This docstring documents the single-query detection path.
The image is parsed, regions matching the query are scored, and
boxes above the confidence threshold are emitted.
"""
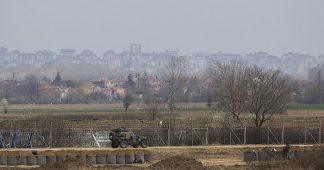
[109,127,147,148]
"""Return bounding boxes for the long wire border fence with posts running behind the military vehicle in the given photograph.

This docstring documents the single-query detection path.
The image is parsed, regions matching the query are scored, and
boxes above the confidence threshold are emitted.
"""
[0,119,323,147]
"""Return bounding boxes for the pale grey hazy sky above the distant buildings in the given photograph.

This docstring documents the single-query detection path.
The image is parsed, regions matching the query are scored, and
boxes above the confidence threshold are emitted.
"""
[0,0,324,55]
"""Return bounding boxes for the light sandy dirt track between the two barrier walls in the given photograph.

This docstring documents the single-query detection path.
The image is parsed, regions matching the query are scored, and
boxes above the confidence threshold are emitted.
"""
[148,145,313,169]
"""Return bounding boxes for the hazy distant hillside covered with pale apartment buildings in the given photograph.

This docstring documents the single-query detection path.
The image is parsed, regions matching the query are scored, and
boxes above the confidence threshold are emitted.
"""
[0,44,324,79]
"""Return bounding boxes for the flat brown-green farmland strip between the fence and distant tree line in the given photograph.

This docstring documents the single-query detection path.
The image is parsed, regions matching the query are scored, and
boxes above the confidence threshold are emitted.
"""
[0,103,324,119]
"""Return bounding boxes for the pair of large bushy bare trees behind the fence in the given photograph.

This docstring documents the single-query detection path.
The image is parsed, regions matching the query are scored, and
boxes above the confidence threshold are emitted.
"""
[215,62,291,127]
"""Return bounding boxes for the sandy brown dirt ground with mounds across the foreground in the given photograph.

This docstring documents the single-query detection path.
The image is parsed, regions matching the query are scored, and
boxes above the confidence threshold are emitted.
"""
[0,145,314,170]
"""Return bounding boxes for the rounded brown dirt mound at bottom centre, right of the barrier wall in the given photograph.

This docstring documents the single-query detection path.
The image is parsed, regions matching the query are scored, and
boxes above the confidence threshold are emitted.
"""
[149,156,206,170]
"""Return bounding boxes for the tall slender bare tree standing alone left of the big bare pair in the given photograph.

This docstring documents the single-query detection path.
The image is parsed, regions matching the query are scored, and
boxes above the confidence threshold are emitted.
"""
[161,56,186,111]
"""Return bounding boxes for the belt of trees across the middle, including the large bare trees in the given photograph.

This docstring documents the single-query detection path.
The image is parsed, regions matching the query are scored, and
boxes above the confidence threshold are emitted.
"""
[0,57,324,127]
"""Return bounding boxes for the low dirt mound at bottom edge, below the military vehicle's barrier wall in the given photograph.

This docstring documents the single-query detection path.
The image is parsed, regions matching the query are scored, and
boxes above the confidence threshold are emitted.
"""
[37,161,97,170]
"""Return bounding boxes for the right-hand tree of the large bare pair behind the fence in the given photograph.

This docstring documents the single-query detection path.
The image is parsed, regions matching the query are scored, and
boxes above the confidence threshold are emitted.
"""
[246,67,291,127]
